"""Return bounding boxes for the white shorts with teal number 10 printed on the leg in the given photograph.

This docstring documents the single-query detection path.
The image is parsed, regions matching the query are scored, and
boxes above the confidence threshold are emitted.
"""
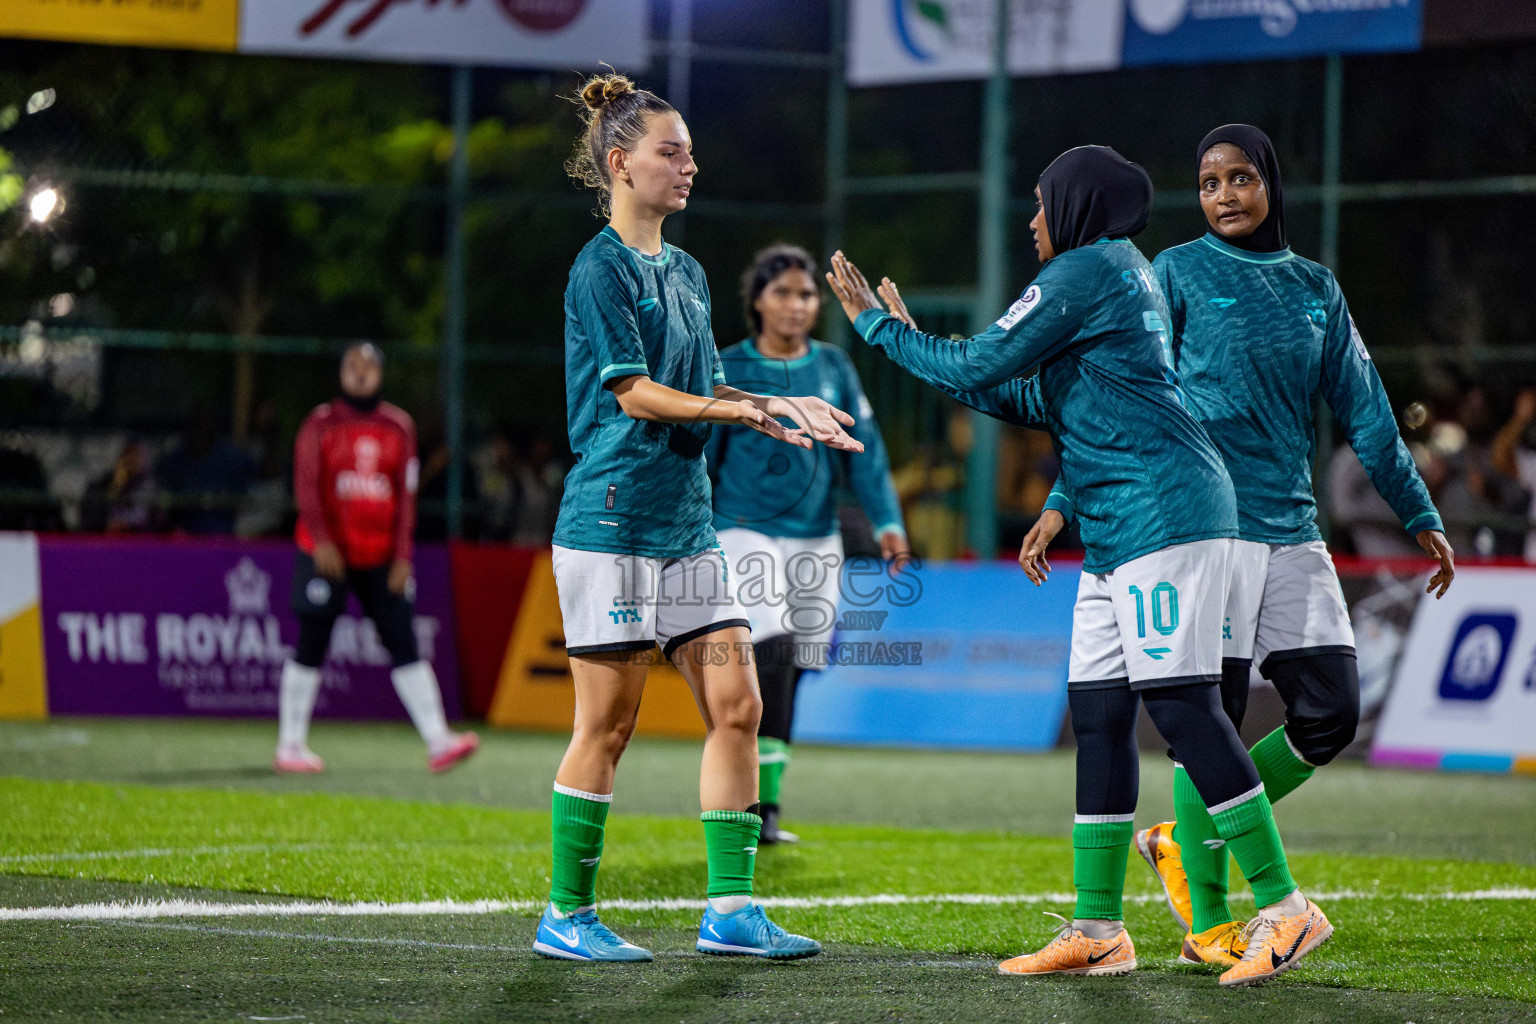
[1066,537,1233,689]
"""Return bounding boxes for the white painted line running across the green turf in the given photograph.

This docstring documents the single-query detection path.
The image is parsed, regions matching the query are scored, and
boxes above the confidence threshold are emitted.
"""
[0,889,1536,921]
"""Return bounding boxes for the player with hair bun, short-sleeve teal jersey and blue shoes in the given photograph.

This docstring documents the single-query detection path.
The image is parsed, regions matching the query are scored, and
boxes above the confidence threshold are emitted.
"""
[533,75,863,961]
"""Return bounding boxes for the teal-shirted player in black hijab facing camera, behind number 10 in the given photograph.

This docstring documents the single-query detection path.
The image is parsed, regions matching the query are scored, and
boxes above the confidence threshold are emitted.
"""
[1025,124,1456,964]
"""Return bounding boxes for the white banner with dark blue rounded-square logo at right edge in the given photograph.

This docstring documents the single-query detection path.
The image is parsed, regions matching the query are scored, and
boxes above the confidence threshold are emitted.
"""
[1372,568,1536,771]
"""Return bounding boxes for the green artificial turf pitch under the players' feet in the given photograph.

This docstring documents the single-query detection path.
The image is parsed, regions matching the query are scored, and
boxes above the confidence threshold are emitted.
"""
[0,722,1536,1024]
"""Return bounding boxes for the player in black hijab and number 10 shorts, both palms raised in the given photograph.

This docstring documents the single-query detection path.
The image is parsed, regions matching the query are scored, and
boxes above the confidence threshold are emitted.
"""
[833,146,1333,986]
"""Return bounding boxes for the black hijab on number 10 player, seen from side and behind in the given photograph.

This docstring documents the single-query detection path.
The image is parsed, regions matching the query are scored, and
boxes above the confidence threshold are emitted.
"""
[1040,146,1152,253]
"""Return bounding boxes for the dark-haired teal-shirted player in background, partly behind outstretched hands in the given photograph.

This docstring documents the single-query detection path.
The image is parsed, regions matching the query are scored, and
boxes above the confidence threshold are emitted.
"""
[707,246,908,843]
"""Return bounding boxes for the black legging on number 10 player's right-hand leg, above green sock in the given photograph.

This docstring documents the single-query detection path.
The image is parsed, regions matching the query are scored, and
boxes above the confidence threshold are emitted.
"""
[1141,683,1258,806]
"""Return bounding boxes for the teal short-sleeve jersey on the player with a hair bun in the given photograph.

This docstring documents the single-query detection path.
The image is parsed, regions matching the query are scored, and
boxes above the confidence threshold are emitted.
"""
[554,227,725,559]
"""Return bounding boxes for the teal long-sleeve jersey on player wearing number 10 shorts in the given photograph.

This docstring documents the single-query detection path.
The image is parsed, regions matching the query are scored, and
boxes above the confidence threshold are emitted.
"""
[854,238,1238,573]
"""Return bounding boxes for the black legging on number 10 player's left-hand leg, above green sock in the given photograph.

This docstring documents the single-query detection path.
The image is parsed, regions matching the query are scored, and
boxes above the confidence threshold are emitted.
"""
[1066,686,1141,814]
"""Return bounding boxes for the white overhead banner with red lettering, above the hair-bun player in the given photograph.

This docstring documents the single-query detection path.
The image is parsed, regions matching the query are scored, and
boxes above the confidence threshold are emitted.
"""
[240,0,648,72]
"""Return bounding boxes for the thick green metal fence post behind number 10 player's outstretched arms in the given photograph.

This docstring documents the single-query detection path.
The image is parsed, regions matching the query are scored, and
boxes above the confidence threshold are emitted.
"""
[965,0,1012,559]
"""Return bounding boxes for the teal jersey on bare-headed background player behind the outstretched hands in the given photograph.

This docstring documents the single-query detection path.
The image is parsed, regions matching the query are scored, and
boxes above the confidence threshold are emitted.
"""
[705,338,905,537]
